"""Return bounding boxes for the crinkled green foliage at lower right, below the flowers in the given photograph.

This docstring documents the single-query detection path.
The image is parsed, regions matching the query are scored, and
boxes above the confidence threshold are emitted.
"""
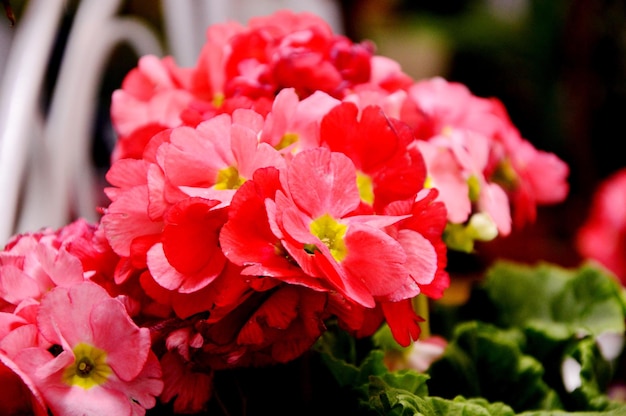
[319,262,626,416]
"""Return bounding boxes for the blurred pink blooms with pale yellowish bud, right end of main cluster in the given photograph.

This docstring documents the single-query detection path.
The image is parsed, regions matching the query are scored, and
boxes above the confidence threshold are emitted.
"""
[401,77,568,247]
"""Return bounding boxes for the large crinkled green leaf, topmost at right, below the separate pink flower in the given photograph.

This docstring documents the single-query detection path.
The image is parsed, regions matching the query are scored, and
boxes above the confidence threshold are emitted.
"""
[483,261,625,340]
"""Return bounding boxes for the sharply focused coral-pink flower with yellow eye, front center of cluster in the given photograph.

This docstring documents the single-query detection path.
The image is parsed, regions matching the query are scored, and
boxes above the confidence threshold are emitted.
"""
[269,148,419,307]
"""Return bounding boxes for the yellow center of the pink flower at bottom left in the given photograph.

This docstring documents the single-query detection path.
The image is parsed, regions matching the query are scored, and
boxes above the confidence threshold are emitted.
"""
[62,342,112,390]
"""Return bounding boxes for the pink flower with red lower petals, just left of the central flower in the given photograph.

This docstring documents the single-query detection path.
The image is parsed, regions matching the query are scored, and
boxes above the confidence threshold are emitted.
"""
[102,109,285,293]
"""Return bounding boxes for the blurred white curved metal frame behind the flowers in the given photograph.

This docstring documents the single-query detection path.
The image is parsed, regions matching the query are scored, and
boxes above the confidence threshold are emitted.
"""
[0,0,341,244]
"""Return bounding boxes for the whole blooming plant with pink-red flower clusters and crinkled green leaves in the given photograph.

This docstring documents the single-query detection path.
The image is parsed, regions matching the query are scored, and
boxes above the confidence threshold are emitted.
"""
[0,7,624,415]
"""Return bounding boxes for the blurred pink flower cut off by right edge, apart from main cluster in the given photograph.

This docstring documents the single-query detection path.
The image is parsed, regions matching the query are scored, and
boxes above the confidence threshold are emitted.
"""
[576,169,626,284]
